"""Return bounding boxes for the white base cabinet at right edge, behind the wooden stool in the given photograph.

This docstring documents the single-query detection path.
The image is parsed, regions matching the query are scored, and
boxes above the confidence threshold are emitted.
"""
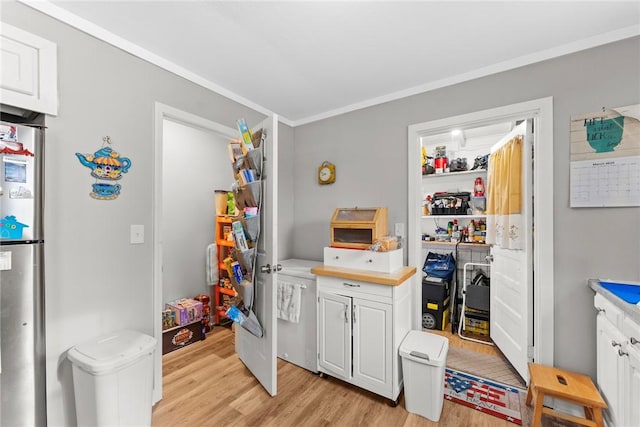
[594,294,640,427]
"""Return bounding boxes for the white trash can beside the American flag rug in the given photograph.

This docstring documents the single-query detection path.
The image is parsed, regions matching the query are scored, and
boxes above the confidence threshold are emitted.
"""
[399,331,449,422]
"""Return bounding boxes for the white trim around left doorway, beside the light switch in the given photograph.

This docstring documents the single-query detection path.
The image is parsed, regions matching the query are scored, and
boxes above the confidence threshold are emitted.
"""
[151,102,237,405]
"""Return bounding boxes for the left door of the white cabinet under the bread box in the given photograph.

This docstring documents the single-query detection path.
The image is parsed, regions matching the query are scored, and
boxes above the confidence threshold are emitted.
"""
[318,291,352,380]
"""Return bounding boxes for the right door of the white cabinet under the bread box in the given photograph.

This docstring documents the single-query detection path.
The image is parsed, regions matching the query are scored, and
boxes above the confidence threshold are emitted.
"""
[353,298,393,396]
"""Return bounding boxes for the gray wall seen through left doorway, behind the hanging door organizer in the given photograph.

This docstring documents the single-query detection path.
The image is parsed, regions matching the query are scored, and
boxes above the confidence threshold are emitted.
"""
[162,120,233,303]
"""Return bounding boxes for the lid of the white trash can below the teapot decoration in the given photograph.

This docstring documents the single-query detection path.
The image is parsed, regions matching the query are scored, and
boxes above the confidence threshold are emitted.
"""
[67,330,156,375]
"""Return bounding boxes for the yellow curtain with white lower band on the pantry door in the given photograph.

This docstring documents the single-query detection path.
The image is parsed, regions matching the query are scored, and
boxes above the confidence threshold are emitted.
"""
[486,136,523,249]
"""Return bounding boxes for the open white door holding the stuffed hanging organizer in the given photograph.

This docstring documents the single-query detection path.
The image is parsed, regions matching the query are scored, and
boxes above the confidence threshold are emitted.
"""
[236,115,278,396]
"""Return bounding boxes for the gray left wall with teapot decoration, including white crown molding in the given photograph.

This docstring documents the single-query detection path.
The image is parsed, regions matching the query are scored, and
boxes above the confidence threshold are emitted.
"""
[2,1,286,426]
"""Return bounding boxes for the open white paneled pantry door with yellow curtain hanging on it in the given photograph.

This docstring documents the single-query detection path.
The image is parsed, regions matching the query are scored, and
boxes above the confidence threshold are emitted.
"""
[489,120,533,384]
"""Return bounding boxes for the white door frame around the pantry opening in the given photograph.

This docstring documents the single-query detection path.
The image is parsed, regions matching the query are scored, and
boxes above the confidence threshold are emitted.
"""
[407,97,554,372]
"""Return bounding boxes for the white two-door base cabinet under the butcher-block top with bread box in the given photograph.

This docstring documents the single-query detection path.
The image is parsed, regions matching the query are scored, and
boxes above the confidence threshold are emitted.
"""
[317,273,411,403]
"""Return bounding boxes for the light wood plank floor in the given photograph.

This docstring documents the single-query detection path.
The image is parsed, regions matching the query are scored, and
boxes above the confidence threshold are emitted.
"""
[153,327,530,427]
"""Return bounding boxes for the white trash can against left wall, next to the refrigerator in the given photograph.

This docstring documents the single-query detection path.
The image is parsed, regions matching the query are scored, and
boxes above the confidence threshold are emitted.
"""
[67,330,156,426]
